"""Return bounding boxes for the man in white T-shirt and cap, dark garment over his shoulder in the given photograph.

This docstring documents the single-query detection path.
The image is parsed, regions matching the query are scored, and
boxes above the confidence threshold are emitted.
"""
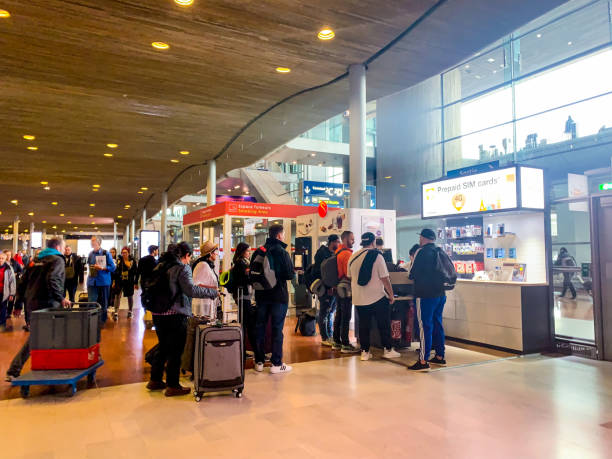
[348,232,400,361]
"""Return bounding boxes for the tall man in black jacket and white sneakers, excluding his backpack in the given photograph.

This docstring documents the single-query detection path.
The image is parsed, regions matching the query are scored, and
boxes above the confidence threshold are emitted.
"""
[251,225,295,374]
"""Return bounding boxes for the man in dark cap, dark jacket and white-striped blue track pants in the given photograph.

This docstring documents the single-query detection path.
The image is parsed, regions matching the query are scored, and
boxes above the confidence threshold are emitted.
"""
[409,228,446,371]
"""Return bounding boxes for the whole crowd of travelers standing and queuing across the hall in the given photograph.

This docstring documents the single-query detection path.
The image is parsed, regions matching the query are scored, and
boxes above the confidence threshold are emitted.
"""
[0,225,446,396]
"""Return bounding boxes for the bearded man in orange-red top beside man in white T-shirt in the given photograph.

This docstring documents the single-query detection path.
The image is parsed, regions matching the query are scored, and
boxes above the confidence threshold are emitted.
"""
[332,231,359,354]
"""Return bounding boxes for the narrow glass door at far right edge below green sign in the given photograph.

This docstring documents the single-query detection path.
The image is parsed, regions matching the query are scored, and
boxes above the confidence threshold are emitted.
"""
[591,196,612,361]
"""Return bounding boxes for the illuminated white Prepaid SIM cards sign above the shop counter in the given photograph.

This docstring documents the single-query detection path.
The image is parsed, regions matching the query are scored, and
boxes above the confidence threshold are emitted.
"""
[421,166,544,218]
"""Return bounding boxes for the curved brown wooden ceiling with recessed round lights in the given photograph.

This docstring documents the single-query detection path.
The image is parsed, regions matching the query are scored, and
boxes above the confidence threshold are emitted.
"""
[0,0,563,235]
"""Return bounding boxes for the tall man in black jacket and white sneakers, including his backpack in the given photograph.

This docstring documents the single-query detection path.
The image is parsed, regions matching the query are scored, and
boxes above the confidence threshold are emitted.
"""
[249,225,295,374]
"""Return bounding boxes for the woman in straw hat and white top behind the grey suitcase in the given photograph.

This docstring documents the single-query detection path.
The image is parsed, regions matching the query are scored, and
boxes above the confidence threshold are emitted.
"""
[191,241,219,319]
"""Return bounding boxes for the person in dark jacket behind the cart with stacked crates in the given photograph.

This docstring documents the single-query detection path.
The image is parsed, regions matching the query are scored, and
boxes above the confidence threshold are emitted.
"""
[6,238,70,381]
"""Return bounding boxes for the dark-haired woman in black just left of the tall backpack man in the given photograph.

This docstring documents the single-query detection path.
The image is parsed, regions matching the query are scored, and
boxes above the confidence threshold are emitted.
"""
[230,242,257,359]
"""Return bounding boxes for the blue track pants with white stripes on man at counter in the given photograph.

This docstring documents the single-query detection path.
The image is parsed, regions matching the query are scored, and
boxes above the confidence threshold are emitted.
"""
[416,296,446,361]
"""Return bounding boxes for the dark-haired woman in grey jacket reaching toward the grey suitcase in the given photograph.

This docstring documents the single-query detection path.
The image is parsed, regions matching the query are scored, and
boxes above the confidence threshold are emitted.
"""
[147,242,218,397]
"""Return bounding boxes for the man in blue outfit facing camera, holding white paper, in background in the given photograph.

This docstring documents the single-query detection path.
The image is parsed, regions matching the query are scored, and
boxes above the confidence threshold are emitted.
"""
[87,236,116,326]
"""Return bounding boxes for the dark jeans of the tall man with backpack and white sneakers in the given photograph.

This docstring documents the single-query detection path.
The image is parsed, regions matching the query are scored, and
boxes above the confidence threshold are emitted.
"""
[255,302,289,366]
